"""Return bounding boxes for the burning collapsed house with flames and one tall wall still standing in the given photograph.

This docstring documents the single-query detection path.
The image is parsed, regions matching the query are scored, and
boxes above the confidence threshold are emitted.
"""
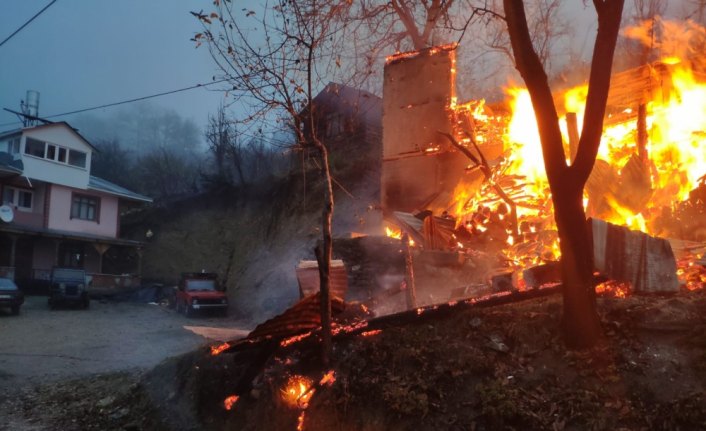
[381,27,706,300]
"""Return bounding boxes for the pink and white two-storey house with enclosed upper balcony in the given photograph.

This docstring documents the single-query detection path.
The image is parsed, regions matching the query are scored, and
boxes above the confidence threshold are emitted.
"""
[0,122,152,287]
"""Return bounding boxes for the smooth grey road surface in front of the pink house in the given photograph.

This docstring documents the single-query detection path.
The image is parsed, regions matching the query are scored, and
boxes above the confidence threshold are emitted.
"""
[0,296,232,392]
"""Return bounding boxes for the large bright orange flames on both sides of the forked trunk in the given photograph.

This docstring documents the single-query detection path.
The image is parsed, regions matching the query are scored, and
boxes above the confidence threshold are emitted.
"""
[449,20,706,276]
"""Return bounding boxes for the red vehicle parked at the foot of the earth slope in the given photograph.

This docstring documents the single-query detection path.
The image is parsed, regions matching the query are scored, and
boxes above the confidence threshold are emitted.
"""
[175,272,228,316]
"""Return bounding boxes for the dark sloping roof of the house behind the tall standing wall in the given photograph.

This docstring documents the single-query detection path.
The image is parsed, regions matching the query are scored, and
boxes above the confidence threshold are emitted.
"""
[314,82,382,122]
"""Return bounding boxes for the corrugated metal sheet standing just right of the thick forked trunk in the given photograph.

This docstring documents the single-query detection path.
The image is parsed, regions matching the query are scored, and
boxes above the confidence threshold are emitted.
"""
[590,219,679,293]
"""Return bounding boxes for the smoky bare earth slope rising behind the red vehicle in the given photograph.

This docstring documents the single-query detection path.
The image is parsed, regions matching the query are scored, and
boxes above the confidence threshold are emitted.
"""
[123,164,381,322]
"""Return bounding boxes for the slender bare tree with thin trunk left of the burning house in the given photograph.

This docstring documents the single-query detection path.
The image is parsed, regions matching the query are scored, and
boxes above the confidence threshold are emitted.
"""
[192,0,348,362]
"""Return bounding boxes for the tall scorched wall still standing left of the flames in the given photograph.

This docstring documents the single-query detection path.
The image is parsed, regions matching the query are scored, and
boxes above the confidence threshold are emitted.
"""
[381,45,465,211]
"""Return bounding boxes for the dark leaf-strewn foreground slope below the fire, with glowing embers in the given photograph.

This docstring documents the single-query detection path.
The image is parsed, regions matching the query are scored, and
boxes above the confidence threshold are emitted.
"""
[8,291,706,431]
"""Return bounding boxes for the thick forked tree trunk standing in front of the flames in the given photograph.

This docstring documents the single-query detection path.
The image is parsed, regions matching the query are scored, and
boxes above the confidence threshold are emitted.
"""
[503,0,624,348]
